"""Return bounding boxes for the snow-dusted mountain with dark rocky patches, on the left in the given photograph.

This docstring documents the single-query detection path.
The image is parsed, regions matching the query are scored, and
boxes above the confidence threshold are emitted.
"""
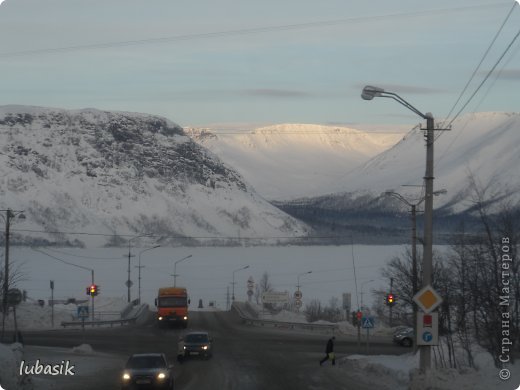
[0,106,307,247]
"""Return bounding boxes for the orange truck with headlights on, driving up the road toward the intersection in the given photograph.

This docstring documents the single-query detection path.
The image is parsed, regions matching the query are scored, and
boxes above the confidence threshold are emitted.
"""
[155,287,190,328]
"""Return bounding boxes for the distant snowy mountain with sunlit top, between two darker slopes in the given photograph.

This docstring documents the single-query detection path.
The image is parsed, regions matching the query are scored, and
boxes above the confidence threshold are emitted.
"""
[185,124,402,200]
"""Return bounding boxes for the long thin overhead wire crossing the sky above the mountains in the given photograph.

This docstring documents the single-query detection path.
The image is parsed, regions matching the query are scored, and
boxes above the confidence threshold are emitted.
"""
[0,4,503,59]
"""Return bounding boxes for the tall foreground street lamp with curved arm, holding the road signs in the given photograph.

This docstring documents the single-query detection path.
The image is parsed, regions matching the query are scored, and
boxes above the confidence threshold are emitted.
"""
[361,85,442,372]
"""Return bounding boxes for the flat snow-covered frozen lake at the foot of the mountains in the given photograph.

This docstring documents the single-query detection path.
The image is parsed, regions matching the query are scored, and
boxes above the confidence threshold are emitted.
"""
[10,245,422,309]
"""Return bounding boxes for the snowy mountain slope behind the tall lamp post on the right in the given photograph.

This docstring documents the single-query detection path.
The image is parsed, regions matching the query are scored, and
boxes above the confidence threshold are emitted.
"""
[334,113,520,211]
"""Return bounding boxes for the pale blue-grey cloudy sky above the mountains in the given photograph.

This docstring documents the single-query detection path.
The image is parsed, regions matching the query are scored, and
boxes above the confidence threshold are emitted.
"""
[0,0,520,128]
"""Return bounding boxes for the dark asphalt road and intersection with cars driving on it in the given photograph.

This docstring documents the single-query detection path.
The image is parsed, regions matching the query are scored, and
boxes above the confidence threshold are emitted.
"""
[16,312,409,390]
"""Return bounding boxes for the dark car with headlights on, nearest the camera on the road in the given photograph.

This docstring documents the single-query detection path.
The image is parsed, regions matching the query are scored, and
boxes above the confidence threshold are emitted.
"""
[121,353,174,390]
